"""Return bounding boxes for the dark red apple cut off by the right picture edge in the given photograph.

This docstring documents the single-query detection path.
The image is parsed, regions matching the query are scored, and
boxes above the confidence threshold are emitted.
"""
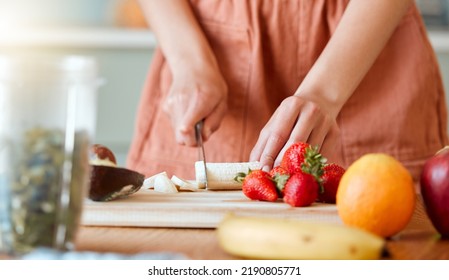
[421,149,449,238]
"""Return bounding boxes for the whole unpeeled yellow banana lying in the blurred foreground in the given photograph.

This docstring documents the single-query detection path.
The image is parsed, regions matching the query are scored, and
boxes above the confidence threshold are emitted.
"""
[217,214,385,260]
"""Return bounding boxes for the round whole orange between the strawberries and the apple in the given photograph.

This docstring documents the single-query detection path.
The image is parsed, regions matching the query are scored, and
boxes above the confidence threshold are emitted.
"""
[336,153,416,237]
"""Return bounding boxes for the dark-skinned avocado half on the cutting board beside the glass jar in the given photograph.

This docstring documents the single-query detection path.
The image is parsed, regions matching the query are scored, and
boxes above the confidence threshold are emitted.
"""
[89,164,145,201]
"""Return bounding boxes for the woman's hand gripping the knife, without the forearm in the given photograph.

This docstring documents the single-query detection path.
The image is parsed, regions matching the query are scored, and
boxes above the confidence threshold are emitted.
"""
[163,62,228,146]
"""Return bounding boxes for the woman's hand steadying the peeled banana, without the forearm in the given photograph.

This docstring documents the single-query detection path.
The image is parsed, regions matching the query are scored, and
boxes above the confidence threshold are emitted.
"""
[250,95,336,170]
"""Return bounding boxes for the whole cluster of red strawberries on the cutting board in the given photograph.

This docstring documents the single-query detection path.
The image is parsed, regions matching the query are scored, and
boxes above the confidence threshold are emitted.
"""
[235,142,345,207]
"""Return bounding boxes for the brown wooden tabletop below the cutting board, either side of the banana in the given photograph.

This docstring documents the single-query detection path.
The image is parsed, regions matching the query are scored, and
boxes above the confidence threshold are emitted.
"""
[77,192,449,260]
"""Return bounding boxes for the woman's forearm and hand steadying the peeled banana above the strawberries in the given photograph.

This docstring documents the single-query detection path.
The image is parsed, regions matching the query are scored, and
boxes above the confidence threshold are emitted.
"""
[250,0,412,169]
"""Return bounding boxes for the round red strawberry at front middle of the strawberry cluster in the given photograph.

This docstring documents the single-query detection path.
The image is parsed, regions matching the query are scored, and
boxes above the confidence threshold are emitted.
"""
[283,172,319,207]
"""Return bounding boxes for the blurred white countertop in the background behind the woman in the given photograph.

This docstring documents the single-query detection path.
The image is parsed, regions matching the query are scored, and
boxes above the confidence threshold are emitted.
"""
[0,27,449,52]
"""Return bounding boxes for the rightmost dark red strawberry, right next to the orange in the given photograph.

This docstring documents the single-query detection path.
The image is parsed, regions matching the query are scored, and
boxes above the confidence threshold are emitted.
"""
[318,163,345,203]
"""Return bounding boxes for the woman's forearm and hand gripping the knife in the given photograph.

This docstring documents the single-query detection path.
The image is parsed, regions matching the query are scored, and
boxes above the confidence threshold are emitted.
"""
[140,0,228,146]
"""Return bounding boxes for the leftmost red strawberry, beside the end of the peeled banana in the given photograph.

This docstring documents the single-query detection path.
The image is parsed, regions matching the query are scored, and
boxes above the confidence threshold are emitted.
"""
[240,170,278,201]
